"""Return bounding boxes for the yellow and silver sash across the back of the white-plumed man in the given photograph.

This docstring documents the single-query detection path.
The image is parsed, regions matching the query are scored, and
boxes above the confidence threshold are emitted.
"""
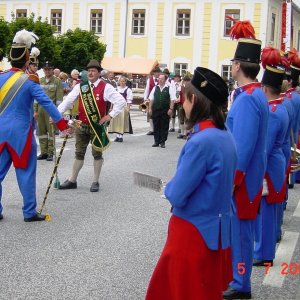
[0,71,28,115]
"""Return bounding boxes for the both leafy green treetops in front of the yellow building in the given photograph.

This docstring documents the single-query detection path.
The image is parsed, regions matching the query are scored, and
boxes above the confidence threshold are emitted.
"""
[0,13,106,73]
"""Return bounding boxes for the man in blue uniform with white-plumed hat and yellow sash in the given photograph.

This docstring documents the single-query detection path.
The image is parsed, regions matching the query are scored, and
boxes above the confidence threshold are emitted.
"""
[0,30,67,222]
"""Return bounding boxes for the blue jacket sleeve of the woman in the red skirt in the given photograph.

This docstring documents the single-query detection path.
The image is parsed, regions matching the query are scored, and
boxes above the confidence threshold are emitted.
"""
[165,140,207,207]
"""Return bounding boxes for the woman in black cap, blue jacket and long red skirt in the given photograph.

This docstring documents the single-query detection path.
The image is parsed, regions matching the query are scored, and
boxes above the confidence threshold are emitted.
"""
[146,67,237,300]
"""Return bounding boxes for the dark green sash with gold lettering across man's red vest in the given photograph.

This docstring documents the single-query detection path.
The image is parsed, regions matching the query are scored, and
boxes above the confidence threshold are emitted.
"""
[80,82,110,152]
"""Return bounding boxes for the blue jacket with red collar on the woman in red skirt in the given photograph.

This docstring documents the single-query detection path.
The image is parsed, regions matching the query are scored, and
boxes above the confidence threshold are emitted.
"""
[165,121,237,250]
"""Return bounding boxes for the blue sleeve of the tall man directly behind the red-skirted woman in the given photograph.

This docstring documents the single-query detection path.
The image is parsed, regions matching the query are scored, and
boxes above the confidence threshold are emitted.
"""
[232,94,260,172]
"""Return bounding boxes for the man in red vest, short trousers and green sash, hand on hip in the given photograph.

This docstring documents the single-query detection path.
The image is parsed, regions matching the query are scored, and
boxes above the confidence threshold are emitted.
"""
[58,59,126,192]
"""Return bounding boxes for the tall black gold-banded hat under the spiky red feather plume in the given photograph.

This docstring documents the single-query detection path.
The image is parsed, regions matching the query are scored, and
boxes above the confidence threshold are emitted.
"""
[232,38,261,64]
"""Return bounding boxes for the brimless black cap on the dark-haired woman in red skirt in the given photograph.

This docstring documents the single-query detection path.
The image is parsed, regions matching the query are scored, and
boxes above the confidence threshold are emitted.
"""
[191,67,229,106]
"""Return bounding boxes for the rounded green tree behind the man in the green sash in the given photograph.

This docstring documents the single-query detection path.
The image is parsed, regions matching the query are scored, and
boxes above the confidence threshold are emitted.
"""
[54,28,106,73]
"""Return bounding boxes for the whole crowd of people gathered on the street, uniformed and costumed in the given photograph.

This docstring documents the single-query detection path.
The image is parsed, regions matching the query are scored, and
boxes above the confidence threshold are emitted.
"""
[0,21,300,300]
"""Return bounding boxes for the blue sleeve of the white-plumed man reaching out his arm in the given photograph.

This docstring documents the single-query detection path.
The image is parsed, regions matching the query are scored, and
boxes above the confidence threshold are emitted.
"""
[30,82,62,123]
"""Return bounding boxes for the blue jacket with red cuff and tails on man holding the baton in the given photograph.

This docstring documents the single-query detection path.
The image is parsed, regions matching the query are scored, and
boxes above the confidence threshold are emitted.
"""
[0,68,67,168]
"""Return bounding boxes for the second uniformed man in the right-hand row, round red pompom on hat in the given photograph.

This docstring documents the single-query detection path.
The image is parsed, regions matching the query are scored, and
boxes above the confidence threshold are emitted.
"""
[253,47,289,266]
